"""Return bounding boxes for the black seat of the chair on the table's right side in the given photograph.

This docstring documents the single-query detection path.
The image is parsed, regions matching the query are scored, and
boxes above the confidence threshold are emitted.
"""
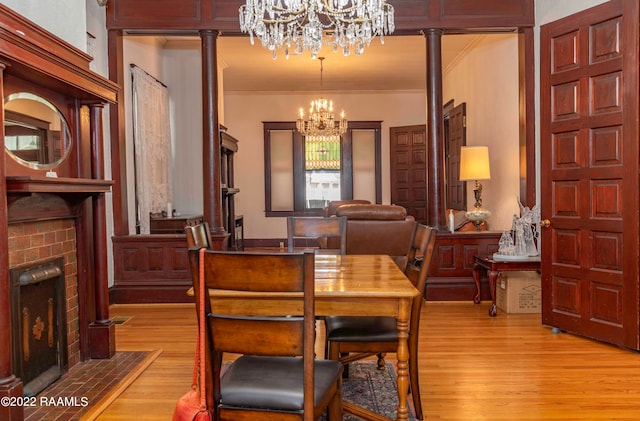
[325,316,398,342]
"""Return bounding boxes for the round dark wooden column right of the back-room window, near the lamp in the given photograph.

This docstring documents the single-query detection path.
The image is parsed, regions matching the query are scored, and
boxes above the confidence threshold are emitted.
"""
[424,29,447,228]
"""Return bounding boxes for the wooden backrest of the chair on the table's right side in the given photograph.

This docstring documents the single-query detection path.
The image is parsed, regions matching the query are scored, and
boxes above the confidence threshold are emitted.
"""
[403,224,438,329]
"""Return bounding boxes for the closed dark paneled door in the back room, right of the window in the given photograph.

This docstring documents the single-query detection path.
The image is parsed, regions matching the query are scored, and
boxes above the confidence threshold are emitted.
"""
[390,125,427,224]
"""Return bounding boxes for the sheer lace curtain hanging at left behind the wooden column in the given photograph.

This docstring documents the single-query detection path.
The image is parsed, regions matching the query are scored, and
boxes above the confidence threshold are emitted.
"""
[131,66,173,234]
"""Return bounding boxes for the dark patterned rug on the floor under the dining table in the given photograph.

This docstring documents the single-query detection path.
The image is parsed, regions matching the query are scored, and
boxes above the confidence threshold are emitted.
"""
[321,361,416,421]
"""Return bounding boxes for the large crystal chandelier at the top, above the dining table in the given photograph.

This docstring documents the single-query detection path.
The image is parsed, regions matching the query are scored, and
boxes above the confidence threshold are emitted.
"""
[239,0,395,59]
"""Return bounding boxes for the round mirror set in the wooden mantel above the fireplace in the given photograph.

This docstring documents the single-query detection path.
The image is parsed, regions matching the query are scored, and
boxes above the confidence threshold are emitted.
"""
[4,92,71,170]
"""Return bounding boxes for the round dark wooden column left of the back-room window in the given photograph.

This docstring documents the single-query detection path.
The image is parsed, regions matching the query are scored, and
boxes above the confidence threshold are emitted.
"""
[200,30,229,250]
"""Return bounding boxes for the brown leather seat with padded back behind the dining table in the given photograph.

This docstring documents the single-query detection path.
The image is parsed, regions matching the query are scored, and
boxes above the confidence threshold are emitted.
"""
[328,204,416,267]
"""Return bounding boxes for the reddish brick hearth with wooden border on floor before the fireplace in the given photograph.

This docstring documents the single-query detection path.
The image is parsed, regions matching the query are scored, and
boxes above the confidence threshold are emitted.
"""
[24,350,162,421]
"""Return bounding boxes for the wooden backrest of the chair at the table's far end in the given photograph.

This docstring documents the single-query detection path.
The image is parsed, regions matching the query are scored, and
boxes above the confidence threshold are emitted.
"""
[287,216,347,254]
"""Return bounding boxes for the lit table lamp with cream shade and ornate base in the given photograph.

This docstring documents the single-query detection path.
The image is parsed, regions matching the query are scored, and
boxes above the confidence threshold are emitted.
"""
[460,146,491,231]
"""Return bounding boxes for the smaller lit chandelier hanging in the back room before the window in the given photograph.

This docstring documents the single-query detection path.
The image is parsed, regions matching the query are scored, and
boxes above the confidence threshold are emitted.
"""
[296,57,347,139]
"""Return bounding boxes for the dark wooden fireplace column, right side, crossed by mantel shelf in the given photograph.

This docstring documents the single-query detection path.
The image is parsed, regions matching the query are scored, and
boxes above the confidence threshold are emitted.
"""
[89,104,116,358]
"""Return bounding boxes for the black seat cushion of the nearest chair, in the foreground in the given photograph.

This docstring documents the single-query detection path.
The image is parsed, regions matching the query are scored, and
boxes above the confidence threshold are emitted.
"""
[220,355,342,411]
